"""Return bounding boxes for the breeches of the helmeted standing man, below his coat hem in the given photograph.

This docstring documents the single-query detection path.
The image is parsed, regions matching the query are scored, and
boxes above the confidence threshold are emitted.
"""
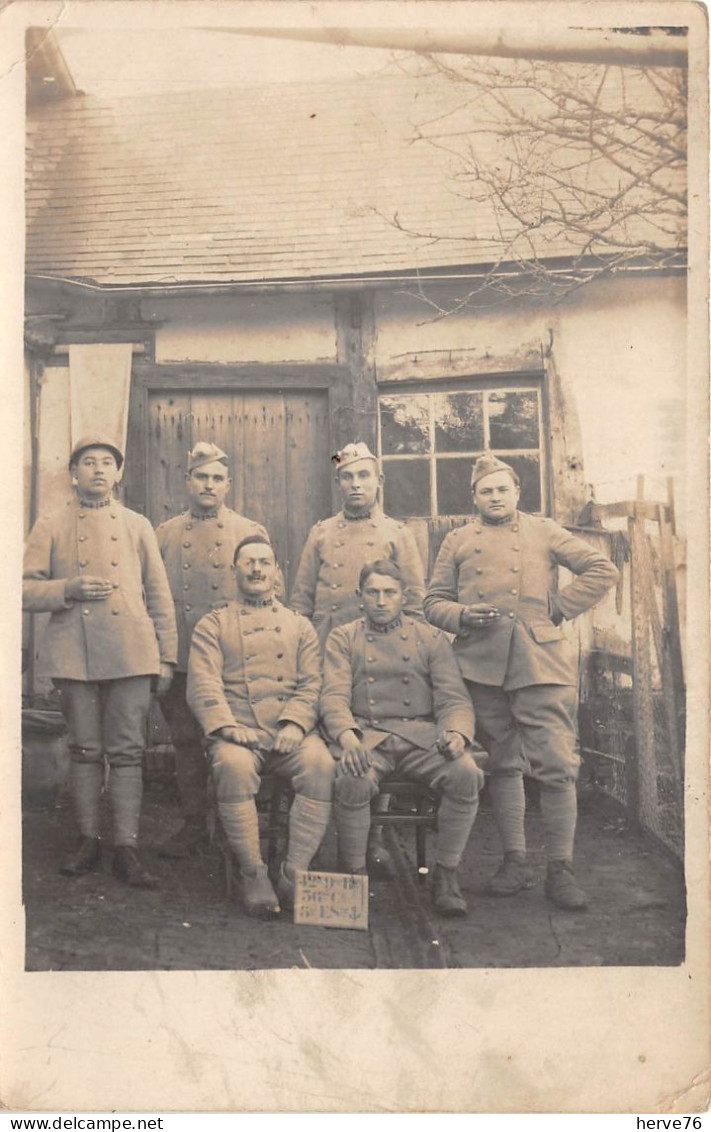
[54,676,151,766]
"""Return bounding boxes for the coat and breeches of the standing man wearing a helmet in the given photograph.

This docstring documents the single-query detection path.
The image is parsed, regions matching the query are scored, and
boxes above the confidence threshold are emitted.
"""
[23,499,177,764]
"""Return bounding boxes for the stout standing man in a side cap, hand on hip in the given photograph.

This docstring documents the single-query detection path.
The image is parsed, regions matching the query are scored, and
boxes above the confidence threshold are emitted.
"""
[425,453,617,910]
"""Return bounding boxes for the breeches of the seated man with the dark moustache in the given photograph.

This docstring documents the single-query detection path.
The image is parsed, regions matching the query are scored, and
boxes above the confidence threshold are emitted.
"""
[207,732,335,801]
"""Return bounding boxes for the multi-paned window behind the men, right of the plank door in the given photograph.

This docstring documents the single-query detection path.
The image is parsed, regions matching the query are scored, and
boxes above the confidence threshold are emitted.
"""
[378,379,545,518]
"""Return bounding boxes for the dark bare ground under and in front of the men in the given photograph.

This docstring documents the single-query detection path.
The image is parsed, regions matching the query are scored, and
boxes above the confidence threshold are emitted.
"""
[24,787,685,971]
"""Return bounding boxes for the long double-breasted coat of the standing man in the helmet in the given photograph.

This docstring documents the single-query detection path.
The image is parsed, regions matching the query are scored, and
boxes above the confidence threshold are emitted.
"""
[23,499,177,680]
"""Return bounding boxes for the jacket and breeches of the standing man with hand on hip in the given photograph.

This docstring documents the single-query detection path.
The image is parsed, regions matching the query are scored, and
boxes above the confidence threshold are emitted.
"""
[425,512,617,786]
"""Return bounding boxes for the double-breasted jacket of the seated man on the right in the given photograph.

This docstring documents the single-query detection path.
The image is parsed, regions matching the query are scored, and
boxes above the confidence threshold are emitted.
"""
[320,616,474,749]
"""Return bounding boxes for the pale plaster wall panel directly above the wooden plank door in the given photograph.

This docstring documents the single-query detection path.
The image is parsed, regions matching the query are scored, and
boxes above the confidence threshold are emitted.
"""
[142,293,336,363]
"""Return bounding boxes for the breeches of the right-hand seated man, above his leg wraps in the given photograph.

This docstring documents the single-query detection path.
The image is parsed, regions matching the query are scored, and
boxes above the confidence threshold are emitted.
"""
[335,735,483,806]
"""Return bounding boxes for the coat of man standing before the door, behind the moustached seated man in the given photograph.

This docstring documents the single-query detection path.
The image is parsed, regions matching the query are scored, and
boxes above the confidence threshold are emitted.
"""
[155,506,268,672]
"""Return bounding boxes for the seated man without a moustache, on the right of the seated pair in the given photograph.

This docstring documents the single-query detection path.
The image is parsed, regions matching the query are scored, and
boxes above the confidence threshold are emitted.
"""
[320,559,483,916]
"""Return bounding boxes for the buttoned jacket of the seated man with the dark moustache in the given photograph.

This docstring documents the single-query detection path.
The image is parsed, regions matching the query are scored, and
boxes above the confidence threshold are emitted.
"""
[187,601,322,747]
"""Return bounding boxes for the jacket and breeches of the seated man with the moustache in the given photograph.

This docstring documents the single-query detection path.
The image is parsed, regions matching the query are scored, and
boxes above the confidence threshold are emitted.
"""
[187,600,333,801]
